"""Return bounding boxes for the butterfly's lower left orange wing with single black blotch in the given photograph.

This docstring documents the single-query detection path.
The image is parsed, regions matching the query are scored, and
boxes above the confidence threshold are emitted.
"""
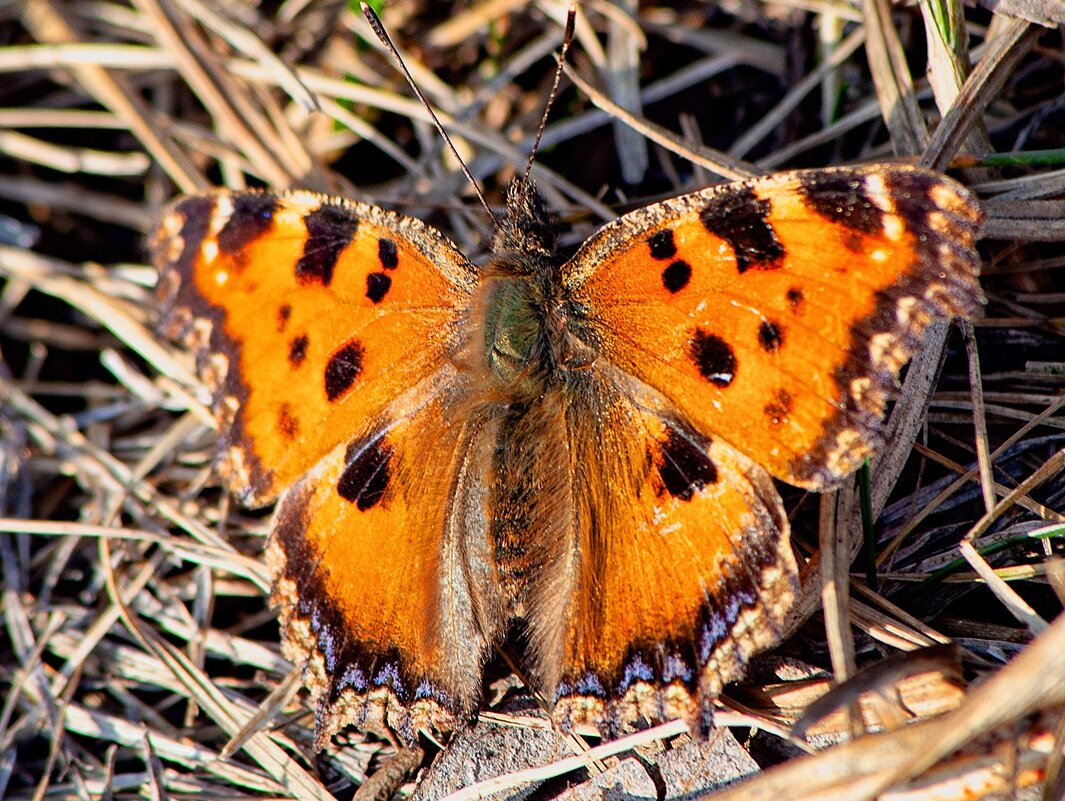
[267,381,504,747]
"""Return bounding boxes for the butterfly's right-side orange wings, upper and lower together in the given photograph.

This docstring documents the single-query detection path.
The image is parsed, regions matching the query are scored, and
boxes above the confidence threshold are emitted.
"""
[530,166,980,729]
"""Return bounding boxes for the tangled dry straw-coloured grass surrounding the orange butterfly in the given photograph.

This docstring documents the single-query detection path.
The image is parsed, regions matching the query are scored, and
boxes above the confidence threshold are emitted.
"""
[0,0,1065,800]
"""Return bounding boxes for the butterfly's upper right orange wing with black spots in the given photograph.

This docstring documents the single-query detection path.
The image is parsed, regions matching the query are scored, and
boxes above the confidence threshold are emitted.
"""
[562,165,981,489]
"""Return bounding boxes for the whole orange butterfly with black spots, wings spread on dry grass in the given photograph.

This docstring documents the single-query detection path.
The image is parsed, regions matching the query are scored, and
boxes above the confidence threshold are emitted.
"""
[152,159,982,746]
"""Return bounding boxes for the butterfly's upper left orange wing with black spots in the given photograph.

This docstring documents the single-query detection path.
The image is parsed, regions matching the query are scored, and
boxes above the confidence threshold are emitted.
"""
[154,192,475,505]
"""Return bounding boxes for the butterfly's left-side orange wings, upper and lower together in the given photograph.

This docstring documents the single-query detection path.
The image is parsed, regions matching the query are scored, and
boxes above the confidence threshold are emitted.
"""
[153,192,489,746]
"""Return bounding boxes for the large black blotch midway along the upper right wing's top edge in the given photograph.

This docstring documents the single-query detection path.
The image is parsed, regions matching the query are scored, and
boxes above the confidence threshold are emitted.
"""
[699,185,784,273]
